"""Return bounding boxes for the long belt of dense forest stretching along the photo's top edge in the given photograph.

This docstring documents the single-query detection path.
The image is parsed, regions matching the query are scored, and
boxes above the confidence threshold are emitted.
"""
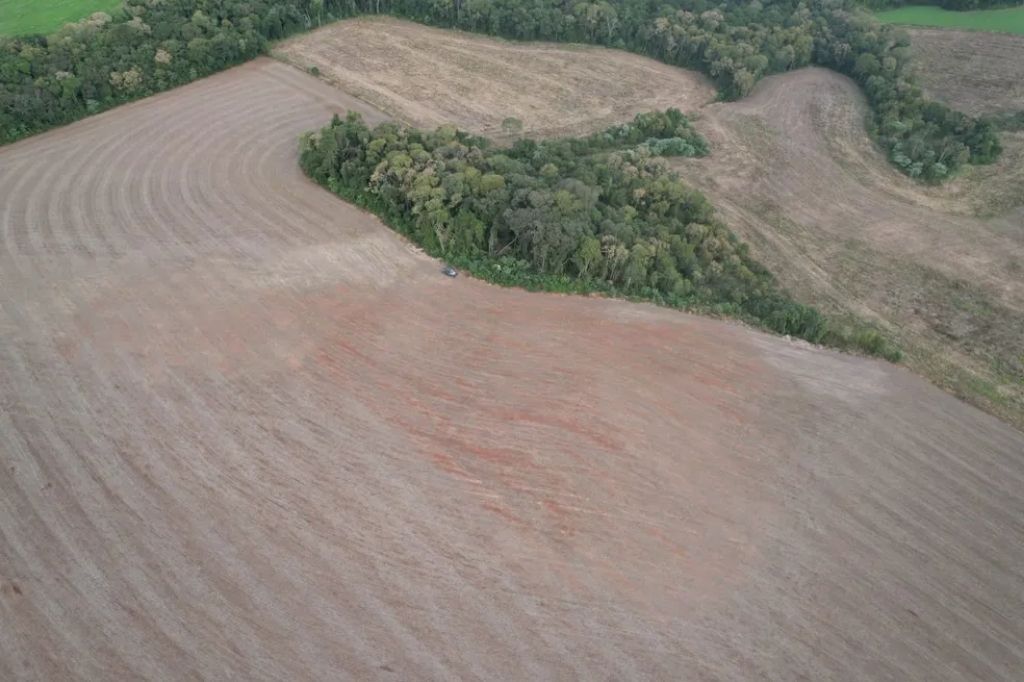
[0,0,999,181]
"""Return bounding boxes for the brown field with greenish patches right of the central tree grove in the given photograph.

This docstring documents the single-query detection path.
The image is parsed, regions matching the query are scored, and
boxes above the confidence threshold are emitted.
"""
[677,69,1024,426]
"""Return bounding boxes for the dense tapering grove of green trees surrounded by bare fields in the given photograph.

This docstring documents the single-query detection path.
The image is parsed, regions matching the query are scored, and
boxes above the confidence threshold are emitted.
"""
[300,110,898,358]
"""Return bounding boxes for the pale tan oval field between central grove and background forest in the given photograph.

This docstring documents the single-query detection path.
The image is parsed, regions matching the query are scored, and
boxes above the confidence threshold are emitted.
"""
[273,17,715,136]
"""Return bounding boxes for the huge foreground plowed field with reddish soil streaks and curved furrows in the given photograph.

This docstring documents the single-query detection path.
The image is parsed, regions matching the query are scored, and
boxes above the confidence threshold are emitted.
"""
[0,59,1024,681]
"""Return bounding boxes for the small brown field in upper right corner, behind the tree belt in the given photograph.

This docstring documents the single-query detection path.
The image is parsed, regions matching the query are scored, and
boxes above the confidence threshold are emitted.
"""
[907,29,1024,116]
